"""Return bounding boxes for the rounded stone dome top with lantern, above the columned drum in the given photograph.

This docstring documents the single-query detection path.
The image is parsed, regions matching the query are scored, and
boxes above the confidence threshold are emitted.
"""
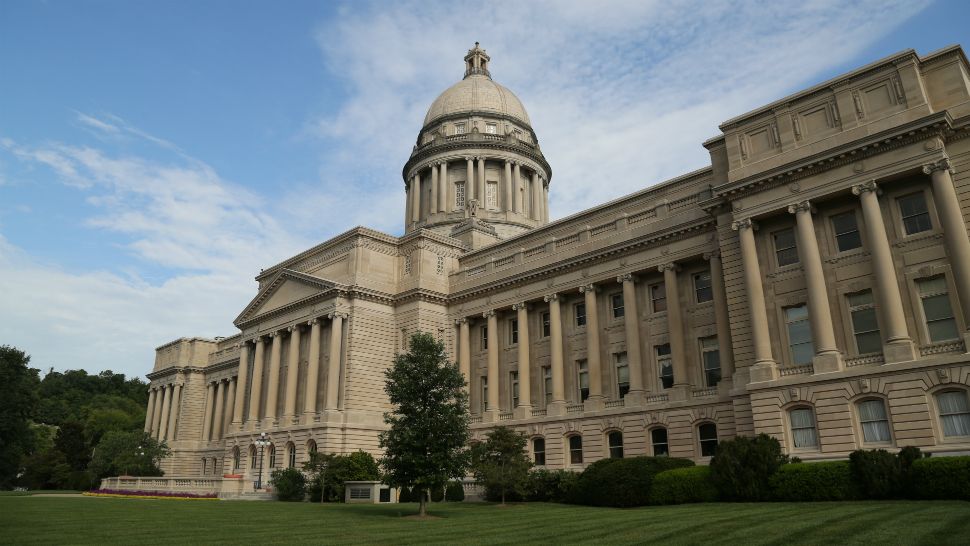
[424,42,532,127]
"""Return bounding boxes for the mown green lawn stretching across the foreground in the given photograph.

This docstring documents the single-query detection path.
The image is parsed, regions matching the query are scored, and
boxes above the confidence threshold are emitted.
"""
[0,497,970,546]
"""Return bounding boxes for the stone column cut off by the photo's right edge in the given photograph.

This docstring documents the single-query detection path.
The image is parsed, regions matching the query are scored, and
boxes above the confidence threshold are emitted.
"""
[923,157,970,340]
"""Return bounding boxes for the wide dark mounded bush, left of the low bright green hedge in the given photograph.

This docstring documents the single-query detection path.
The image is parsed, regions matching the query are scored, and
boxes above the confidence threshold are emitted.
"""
[568,457,694,507]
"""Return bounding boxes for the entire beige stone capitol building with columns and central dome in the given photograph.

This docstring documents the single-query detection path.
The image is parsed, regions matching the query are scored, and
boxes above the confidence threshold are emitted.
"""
[115,44,970,494]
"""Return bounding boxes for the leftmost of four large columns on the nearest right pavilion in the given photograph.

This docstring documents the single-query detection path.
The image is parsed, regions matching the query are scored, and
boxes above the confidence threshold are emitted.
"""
[731,218,778,383]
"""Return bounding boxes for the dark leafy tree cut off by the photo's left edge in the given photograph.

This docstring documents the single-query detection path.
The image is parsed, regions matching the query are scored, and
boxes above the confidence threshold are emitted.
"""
[0,345,38,489]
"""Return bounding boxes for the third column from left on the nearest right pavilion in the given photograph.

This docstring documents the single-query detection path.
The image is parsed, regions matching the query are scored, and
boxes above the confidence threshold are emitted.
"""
[852,181,916,364]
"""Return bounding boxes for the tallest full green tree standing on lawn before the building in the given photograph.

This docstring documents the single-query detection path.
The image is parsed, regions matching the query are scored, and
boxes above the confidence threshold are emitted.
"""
[380,332,468,516]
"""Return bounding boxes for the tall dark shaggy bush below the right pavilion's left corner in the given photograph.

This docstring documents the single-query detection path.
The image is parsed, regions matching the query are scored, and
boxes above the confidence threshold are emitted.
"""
[711,434,788,501]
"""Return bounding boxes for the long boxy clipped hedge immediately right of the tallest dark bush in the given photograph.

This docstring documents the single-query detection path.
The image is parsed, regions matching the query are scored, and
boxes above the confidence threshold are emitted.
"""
[769,461,860,502]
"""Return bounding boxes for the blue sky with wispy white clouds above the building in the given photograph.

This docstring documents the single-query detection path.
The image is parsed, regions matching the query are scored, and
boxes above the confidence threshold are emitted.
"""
[0,0,970,376]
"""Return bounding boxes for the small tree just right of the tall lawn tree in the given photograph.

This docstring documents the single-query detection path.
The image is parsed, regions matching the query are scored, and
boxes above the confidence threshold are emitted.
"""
[471,427,532,505]
